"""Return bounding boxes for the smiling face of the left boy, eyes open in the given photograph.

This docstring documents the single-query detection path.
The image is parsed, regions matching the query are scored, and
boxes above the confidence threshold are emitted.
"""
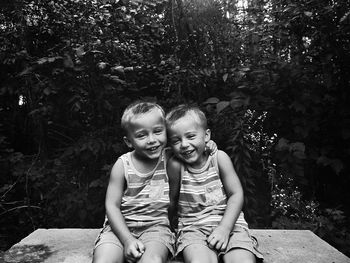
[124,109,167,159]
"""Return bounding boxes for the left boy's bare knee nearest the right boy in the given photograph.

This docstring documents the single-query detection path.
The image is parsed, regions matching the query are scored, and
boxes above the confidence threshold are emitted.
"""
[138,241,169,263]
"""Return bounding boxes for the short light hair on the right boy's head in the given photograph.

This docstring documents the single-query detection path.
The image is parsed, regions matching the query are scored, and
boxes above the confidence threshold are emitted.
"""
[165,104,208,130]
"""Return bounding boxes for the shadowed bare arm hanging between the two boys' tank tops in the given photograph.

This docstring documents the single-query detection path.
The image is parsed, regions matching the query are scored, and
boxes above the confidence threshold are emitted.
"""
[167,157,181,230]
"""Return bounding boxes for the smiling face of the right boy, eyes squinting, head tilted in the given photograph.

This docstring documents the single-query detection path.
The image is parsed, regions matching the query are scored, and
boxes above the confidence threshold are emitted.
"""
[168,114,210,168]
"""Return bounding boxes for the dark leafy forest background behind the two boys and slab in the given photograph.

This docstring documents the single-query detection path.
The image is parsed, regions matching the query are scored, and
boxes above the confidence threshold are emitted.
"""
[0,0,350,256]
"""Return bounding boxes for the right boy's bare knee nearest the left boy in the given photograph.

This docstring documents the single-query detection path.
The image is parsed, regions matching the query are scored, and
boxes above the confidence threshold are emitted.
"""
[183,244,218,263]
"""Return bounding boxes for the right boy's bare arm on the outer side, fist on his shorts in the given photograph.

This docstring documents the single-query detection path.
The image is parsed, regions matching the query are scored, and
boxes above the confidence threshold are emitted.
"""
[208,151,244,250]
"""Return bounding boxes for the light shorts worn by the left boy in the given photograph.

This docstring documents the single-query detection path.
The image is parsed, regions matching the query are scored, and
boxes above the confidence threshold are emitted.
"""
[94,224,175,255]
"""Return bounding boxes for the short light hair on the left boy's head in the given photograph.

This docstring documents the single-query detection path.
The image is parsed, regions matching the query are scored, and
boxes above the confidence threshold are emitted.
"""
[121,101,165,133]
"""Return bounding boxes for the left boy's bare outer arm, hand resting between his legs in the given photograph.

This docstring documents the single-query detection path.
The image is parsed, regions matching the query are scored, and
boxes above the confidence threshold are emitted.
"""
[105,159,144,261]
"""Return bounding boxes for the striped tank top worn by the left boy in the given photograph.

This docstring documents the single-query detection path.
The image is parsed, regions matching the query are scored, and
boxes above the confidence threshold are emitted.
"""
[115,150,169,229]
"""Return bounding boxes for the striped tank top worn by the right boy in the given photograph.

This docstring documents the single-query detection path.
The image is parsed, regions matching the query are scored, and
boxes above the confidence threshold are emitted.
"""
[178,151,248,235]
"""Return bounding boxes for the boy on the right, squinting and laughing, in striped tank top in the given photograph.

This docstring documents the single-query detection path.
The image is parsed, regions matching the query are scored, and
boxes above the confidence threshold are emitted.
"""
[166,105,263,263]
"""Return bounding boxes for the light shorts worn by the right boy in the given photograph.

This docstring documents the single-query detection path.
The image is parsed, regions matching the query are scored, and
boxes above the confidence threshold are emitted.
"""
[175,225,264,259]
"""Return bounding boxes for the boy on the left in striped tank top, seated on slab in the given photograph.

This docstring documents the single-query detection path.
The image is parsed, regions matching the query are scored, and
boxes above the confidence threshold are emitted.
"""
[93,102,175,263]
